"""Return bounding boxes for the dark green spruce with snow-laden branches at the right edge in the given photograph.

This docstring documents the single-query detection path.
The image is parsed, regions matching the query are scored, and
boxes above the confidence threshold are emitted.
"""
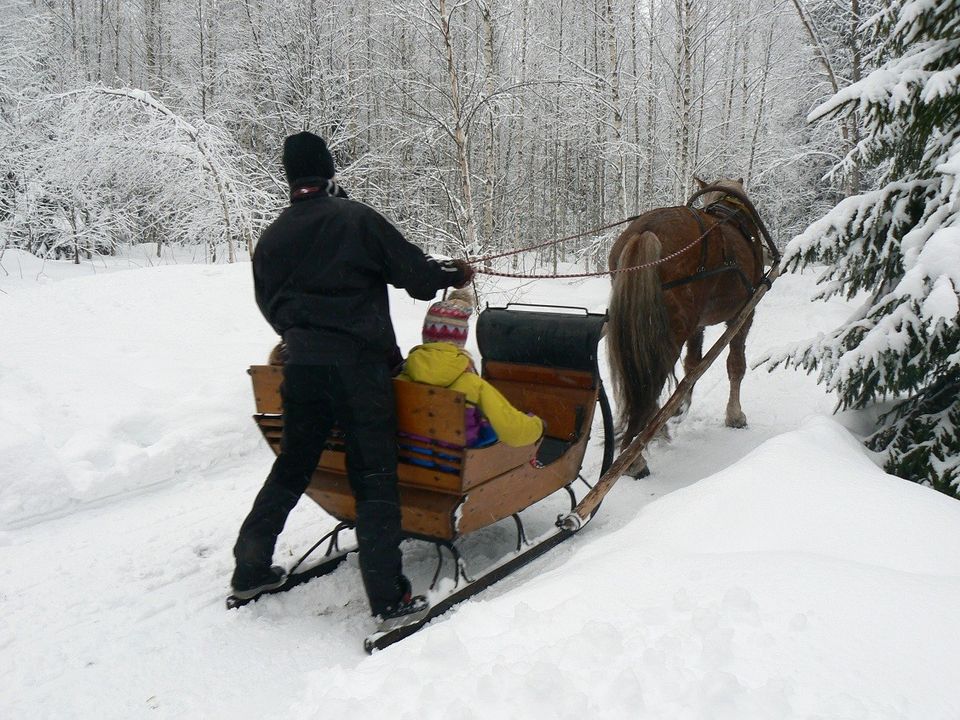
[771,0,960,495]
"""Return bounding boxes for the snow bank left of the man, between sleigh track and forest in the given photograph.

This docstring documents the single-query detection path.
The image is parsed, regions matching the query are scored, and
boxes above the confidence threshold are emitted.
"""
[0,256,275,527]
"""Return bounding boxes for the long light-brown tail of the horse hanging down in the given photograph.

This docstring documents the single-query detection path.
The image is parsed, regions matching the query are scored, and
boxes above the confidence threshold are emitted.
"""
[607,231,677,440]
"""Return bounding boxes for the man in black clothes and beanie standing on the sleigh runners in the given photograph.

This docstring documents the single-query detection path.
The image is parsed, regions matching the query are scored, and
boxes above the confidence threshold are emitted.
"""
[231,132,473,618]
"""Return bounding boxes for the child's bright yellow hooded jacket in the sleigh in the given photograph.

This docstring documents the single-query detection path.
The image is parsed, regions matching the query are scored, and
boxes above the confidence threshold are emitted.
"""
[397,343,543,447]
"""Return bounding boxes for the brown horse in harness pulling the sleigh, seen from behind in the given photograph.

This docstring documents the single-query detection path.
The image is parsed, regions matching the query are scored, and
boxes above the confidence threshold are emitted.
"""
[607,178,763,477]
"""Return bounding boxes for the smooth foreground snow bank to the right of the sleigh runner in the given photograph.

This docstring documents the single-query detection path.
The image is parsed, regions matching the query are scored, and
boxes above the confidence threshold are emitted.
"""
[291,418,960,719]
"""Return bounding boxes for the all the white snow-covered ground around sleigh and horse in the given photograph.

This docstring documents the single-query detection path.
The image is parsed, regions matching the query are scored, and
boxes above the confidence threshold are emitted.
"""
[0,251,960,720]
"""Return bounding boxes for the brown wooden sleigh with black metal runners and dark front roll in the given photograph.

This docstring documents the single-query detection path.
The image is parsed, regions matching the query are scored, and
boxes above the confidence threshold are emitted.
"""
[240,306,613,650]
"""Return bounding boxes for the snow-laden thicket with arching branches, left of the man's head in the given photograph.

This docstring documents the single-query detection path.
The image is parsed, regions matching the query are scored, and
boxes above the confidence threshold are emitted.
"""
[0,86,271,262]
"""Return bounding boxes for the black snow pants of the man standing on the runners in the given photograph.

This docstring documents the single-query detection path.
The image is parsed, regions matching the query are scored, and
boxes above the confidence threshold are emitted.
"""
[233,363,407,615]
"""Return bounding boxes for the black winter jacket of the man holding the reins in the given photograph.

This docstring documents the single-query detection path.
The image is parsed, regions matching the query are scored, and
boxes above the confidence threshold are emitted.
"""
[253,195,464,365]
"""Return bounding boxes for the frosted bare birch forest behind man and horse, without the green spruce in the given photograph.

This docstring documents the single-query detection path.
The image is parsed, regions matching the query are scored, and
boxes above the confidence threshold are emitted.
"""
[0,0,878,271]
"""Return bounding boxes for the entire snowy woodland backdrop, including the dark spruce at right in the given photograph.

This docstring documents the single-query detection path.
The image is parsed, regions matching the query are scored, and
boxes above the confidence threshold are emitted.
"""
[7,0,960,495]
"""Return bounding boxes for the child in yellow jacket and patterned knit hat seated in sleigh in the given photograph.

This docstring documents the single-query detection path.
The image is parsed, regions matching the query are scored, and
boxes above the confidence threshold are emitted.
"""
[397,288,543,447]
